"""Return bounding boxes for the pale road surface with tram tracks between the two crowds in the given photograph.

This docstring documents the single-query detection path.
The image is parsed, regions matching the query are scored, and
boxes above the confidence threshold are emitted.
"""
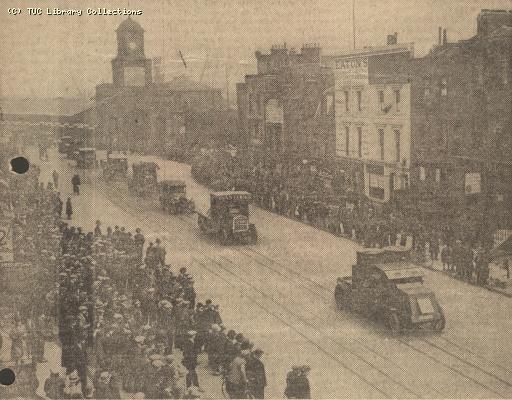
[6,146,512,398]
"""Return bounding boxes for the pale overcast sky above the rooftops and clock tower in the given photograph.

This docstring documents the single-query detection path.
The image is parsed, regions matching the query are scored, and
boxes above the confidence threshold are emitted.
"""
[0,0,512,97]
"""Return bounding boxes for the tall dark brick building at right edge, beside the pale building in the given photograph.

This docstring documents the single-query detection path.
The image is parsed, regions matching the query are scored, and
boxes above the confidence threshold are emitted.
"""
[406,10,512,238]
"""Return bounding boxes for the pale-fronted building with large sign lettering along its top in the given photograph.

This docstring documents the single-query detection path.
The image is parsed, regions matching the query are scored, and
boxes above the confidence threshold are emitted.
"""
[325,38,414,205]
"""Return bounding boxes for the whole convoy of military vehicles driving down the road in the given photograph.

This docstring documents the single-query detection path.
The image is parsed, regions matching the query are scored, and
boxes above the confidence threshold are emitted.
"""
[55,147,446,334]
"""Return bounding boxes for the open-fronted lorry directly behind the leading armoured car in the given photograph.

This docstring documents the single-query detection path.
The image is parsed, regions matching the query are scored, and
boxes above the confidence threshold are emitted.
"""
[197,191,258,245]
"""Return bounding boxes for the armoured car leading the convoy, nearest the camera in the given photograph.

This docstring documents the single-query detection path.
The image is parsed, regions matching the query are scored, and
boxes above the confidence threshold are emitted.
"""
[334,247,446,335]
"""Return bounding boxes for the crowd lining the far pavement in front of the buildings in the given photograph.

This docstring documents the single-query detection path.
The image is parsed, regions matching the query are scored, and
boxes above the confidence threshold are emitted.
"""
[192,151,500,286]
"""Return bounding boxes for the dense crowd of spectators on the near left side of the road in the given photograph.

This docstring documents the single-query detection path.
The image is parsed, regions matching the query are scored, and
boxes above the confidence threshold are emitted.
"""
[0,145,316,399]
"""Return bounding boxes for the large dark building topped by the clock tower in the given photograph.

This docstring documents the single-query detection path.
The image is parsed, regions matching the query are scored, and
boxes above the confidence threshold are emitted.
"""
[96,18,229,156]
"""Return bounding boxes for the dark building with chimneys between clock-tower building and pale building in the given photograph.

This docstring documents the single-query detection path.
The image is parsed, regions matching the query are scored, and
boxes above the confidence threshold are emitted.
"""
[237,45,334,166]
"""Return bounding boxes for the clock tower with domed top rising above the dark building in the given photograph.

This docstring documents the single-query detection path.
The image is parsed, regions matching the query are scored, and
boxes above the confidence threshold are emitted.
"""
[112,17,152,86]
